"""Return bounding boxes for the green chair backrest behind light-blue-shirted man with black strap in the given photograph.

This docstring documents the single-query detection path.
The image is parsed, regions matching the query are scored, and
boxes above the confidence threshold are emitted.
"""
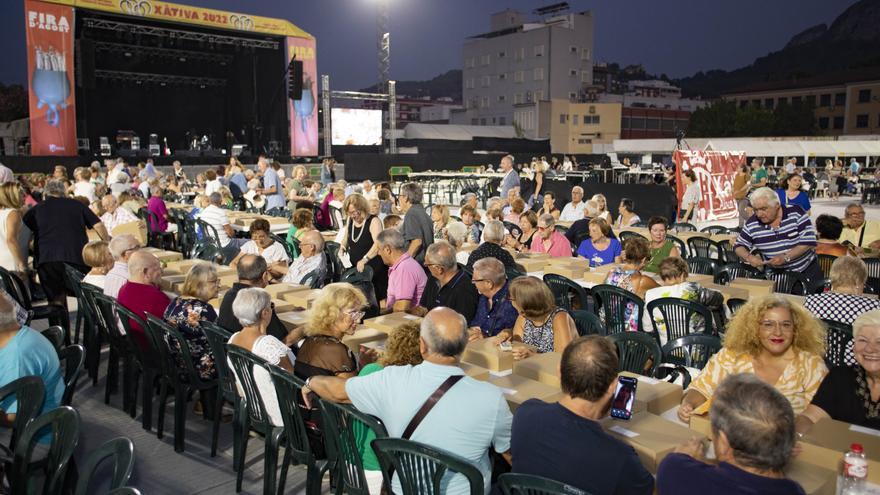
[373,438,485,495]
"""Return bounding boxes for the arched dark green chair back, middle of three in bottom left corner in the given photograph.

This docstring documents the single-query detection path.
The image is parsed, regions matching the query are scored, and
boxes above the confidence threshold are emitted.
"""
[10,406,80,495]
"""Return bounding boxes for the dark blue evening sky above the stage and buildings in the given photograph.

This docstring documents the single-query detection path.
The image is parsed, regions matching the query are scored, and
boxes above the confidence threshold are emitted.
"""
[0,0,855,89]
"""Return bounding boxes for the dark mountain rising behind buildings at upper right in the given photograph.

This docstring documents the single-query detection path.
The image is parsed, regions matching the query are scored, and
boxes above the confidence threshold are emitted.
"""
[675,0,880,98]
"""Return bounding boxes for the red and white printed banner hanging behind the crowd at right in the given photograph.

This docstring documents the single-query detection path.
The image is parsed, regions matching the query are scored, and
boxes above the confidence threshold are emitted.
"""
[672,150,746,222]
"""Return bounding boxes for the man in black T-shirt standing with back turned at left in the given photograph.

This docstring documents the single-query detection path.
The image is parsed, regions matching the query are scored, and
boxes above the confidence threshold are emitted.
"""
[22,180,110,308]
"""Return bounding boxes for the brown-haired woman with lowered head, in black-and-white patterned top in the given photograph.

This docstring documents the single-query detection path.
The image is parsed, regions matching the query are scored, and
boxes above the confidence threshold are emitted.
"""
[496,277,577,360]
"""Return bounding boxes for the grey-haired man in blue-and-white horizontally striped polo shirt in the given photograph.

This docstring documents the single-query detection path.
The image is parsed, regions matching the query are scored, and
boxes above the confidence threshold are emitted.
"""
[734,187,823,280]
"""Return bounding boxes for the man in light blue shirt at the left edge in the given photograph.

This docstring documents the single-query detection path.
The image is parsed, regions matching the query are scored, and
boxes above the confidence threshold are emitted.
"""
[0,292,64,434]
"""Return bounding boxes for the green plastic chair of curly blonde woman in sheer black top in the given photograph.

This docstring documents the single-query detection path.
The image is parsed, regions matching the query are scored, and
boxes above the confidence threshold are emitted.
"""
[266,365,338,495]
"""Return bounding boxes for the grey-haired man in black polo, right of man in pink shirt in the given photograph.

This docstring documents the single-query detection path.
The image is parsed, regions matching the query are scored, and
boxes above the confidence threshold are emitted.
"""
[407,241,480,321]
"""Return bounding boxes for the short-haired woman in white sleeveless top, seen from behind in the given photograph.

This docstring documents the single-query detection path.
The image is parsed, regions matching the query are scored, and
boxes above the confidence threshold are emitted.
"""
[229,288,295,426]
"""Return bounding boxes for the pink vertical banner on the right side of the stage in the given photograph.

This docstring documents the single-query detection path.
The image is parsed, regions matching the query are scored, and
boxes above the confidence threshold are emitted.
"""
[287,37,318,156]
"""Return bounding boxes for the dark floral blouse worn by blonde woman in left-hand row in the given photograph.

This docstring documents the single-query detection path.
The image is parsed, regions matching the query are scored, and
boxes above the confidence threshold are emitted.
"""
[164,297,217,380]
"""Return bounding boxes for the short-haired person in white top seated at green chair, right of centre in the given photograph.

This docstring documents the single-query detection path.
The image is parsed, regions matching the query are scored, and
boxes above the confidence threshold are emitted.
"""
[642,257,726,345]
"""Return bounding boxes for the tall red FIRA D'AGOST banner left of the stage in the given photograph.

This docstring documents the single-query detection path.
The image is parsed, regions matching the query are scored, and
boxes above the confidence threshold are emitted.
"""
[24,0,76,156]
